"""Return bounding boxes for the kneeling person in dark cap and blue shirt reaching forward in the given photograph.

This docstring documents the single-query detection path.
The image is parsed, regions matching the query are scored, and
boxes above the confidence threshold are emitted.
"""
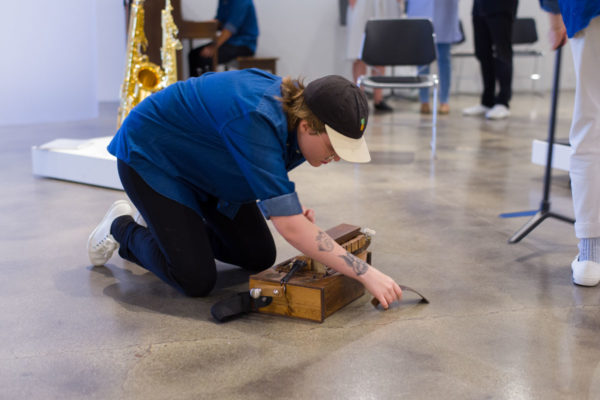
[88,69,402,308]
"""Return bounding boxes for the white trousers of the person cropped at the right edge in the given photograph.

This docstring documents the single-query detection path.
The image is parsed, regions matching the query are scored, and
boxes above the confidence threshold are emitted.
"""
[569,17,600,239]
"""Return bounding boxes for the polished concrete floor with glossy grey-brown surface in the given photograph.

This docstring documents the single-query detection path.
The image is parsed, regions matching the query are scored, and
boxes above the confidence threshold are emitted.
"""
[0,93,600,399]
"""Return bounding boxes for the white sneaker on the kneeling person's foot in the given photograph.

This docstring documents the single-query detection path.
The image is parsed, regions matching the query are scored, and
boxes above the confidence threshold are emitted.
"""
[88,200,135,267]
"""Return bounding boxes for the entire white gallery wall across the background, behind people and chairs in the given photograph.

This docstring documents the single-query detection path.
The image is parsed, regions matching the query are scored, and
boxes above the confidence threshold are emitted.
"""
[0,0,574,125]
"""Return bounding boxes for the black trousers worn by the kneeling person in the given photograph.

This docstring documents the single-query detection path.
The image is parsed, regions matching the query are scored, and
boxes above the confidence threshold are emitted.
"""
[111,160,276,296]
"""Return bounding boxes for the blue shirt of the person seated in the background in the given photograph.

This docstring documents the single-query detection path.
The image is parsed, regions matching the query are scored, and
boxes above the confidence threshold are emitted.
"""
[215,0,258,53]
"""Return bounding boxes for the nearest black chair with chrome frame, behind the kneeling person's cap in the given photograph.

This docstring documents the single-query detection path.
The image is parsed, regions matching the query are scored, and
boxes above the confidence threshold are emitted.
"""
[357,18,438,157]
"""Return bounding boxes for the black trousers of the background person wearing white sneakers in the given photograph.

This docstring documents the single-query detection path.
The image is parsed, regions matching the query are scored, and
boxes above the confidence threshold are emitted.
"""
[473,13,515,107]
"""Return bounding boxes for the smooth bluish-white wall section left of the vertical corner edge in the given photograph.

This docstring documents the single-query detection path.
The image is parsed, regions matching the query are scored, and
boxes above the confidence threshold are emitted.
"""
[0,0,98,125]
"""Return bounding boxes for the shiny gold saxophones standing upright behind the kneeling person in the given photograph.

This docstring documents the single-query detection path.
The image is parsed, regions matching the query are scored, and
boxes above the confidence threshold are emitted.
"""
[117,0,181,129]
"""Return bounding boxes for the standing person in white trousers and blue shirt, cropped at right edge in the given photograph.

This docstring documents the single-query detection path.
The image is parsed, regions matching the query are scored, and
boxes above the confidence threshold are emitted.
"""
[540,0,600,286]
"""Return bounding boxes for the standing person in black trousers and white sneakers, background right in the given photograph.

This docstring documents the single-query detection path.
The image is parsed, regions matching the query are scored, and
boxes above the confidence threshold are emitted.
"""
[463,0,518,119]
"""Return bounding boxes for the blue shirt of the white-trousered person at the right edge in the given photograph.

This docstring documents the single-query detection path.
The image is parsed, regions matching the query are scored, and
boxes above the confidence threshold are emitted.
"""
[540,0,600,38]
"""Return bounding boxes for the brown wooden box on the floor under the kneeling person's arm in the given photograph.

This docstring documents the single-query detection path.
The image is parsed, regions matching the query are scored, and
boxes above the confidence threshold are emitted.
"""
[250,224,370,322]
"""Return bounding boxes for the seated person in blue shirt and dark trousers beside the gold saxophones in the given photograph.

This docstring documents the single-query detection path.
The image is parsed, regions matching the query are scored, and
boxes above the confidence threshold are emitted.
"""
[188,0,258,76]
